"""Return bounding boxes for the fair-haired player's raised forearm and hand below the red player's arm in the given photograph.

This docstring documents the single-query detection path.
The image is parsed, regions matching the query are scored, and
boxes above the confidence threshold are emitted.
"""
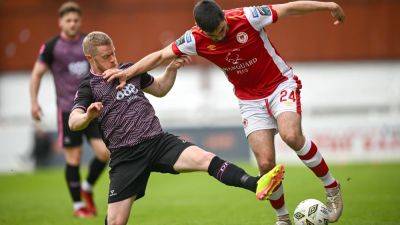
[143,56,191,98]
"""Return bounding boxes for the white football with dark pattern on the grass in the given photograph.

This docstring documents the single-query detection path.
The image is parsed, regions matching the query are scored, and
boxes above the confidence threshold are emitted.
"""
[293,199,329,225]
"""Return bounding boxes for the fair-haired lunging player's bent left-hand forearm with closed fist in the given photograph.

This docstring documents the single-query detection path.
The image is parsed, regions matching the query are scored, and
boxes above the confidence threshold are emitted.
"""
[68,102,103,131]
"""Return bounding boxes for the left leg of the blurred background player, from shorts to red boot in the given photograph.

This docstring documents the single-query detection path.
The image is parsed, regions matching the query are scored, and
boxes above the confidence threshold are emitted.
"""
[58,113,93,217]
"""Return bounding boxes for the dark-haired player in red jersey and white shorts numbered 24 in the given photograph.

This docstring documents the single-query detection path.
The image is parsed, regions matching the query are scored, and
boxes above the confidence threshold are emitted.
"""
[105,0,345,225]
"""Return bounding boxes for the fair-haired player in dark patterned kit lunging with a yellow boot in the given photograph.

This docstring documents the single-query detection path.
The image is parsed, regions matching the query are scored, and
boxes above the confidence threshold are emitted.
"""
[69,31,284,225]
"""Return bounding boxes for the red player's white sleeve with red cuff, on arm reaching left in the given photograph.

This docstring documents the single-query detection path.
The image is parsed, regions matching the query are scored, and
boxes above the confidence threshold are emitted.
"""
[172,30,197,56]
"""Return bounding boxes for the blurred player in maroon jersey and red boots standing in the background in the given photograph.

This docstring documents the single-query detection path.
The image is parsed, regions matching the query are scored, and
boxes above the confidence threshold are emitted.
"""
[30,2,109,218]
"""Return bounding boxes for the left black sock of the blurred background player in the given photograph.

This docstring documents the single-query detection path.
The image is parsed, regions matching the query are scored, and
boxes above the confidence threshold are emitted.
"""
[65,164,81,202]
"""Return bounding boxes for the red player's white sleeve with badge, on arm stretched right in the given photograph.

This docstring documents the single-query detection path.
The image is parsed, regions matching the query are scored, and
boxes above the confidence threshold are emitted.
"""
[243,5,278,31]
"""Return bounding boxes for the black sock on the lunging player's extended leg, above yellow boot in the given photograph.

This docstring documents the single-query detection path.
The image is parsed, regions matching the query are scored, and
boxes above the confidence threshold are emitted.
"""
[208,156,258,192]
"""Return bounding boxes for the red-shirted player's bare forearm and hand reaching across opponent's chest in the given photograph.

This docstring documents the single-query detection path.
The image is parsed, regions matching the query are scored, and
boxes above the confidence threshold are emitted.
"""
[104,45,178,89]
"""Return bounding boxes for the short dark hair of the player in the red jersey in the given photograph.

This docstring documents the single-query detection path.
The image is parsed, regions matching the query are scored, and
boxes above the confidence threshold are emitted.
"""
[193,0,225,32]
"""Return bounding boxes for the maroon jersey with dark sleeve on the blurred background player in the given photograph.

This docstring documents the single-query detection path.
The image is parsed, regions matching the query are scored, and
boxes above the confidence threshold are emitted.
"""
[39,35,89,112]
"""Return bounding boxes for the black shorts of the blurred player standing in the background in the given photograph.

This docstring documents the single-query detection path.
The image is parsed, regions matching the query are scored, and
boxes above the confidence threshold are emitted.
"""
[58,112,101,148]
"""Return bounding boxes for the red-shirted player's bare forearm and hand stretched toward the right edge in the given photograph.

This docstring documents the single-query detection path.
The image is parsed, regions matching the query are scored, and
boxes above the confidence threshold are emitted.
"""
[273,1,345,25]
